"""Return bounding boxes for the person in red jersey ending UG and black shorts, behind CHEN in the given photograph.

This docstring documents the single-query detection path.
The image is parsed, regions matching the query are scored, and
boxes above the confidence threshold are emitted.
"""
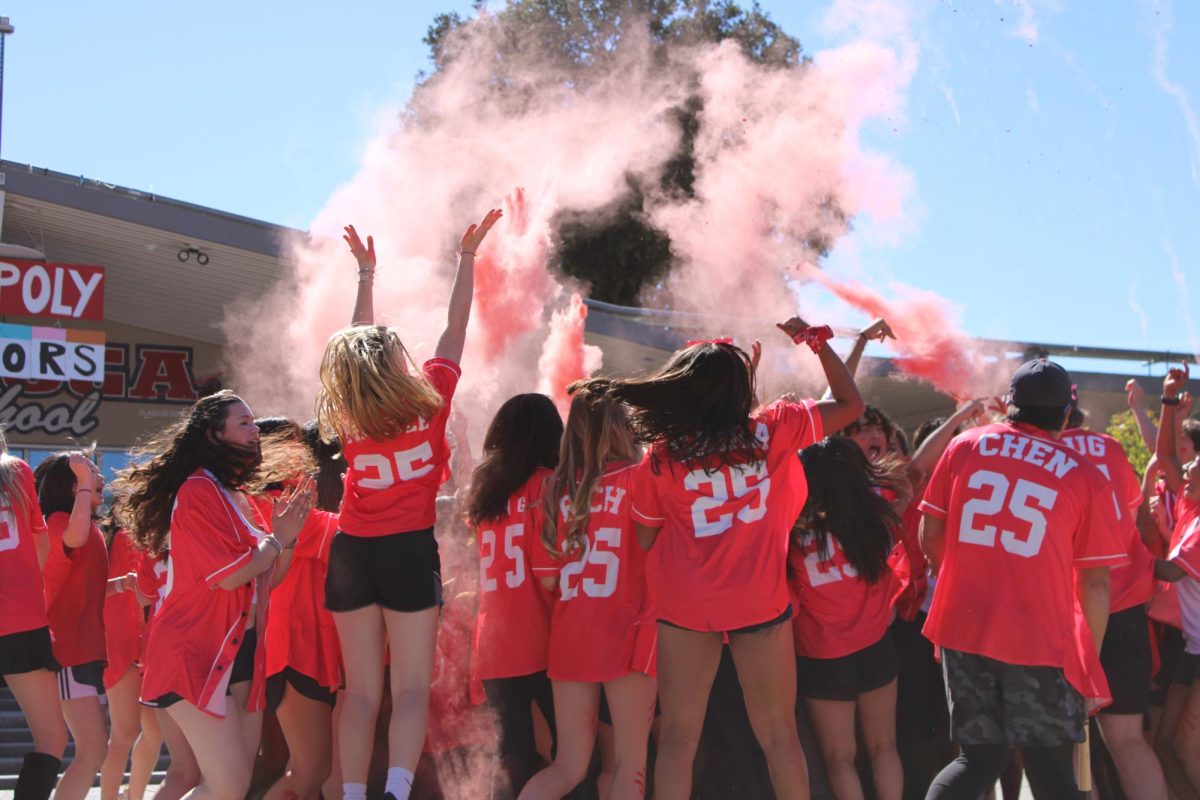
[1062,403,1166,800]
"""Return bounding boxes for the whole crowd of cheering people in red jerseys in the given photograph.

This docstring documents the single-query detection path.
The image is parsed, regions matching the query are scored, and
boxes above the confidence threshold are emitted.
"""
[0,211,1200,800]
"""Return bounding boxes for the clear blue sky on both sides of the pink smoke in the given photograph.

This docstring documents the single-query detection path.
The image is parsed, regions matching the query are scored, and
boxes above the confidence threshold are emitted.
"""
[0,0,1200,371]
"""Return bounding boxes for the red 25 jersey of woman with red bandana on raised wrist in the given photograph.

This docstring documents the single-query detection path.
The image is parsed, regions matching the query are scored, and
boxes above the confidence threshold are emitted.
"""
[632,401,824,631]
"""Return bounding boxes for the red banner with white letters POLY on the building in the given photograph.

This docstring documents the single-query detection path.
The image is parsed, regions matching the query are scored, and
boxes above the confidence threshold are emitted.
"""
[0,258,104,320]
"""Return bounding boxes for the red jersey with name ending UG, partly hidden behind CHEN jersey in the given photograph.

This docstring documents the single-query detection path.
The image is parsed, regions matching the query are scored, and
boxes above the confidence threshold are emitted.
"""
[1061,429,1154,614]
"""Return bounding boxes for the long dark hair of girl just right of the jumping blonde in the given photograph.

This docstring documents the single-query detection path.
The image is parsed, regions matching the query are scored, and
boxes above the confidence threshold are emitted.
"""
[466,393,563,525]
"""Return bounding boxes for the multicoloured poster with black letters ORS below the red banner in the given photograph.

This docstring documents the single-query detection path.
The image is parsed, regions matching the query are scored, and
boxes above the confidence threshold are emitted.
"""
[0,324,104,384]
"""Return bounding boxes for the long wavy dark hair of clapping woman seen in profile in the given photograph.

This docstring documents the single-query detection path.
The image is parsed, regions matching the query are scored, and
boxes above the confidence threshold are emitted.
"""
[113,390,263,557]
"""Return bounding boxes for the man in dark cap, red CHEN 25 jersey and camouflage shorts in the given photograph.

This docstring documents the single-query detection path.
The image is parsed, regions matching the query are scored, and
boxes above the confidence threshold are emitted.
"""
[920,359,1128,800]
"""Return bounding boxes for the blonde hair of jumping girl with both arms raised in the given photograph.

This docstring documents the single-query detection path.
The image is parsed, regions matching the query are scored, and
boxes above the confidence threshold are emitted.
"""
[317,325,442,444]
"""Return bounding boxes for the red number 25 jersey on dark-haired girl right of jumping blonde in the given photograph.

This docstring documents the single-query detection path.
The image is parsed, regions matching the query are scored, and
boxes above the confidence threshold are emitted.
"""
[472,468,553,680]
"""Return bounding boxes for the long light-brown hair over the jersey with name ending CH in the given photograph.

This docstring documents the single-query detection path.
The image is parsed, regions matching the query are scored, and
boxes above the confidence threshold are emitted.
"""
[541,381,638,555]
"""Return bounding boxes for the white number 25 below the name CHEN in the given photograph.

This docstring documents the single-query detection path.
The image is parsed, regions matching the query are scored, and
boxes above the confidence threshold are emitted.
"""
[959,469,1058,558]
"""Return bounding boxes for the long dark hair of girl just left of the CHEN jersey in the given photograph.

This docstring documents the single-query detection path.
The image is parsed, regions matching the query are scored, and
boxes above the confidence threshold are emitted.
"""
[792,437,902,583]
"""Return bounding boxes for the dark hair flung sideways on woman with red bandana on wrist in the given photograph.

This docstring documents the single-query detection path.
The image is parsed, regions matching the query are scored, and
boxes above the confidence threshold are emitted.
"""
[573,342,764,471]
